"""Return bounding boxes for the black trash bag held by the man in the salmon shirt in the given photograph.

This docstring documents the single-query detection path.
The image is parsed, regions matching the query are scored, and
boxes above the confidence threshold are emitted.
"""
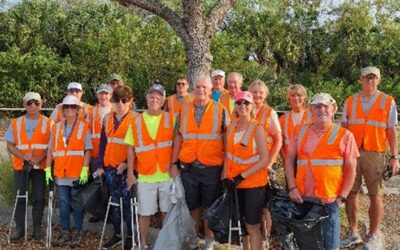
[268,195,328,250]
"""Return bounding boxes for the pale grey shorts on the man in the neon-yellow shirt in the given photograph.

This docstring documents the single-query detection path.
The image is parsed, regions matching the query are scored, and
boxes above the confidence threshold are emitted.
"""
[137,180,172,216]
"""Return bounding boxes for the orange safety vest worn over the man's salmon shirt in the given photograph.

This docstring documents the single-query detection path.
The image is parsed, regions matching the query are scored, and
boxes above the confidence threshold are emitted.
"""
[296,123,346,200]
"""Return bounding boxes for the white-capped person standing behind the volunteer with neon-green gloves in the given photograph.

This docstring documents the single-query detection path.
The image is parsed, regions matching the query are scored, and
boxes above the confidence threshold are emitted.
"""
[50,82,93,123]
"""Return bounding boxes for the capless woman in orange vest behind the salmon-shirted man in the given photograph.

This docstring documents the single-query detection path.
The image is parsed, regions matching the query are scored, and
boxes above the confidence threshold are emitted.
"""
[279,84,312,161]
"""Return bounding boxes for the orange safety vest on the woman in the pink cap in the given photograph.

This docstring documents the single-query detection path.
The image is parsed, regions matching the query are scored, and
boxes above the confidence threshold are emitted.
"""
[226,120,268,188]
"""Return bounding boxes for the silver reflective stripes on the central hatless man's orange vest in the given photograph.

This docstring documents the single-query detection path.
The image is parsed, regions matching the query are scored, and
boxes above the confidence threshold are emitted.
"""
[182,101,222,140]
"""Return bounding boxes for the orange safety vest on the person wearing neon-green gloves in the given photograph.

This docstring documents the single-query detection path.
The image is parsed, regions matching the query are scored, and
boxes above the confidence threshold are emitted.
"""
[51,120,89,178]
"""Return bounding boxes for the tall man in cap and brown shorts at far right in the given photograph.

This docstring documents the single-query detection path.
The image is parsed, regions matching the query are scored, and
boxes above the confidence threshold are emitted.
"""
[342,67,399,250]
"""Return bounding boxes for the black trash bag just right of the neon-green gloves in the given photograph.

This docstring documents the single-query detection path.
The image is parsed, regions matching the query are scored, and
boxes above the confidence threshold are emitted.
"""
[80,177,108,219]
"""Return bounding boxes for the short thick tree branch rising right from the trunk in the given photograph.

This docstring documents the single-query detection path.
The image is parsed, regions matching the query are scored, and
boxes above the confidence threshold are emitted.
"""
[206,0,236,37]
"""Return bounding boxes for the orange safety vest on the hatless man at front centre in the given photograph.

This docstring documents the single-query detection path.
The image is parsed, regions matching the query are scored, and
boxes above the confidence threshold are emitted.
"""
[179,100,224,166]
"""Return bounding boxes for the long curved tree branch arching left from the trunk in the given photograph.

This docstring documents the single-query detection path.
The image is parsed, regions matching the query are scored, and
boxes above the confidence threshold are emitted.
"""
[117,0,188,40]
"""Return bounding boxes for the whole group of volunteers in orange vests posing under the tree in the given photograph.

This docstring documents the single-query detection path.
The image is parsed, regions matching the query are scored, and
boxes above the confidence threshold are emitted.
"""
[5,67,399,250]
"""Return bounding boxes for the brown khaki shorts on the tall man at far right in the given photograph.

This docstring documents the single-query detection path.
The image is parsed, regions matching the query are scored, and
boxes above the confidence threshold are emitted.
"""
[351,148,386,195]
